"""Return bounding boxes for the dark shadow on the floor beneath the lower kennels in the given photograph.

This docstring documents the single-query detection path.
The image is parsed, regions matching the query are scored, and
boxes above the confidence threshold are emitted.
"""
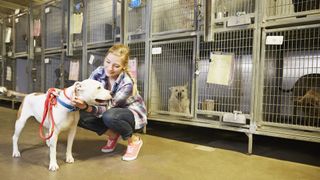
[147,121,320,166]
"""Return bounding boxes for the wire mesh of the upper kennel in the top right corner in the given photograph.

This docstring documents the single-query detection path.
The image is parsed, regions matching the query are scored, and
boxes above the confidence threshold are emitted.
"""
[266,0,320,17]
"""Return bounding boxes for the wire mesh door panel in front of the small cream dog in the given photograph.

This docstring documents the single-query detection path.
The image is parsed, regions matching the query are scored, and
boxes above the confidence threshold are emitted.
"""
[150,40,194,115]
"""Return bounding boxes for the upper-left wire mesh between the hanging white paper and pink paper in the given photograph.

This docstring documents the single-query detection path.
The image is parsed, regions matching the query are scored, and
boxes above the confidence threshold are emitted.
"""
[15,14,29,53]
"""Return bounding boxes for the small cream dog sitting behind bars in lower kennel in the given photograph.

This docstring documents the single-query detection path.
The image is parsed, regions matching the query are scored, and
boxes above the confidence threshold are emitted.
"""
[168,85,190,114]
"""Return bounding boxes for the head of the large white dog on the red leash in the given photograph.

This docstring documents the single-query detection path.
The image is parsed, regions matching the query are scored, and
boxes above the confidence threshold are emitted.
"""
[74,79,112,105]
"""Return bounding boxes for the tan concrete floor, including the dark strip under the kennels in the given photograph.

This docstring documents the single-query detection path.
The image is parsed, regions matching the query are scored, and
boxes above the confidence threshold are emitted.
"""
[0,105,320,180]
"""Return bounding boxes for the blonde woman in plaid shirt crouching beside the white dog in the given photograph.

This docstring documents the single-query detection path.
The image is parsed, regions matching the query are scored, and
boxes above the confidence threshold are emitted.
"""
[74,44,147,161]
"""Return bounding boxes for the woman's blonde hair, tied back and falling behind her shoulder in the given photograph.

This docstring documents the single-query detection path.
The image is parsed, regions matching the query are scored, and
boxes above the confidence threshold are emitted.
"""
[107,44,138,96]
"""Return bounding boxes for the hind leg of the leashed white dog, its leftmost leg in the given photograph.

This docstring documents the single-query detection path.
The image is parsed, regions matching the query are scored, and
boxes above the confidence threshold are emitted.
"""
[12,102,31,157]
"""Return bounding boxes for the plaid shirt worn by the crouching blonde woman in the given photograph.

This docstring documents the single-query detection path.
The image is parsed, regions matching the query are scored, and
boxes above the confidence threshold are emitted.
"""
[89,66,147,129]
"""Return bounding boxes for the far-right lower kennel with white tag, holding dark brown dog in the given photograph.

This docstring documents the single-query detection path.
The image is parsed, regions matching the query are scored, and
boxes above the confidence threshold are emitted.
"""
[257,24,320,141]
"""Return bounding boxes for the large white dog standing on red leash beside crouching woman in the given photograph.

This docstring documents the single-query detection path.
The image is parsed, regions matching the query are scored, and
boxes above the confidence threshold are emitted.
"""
[12,79,112,171]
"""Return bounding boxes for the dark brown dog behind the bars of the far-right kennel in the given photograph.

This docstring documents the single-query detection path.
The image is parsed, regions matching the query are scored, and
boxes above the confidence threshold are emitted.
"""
[280,73,320,116]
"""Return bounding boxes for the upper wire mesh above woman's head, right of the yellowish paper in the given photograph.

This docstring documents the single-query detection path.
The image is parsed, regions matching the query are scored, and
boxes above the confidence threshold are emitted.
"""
[88,0,113,43]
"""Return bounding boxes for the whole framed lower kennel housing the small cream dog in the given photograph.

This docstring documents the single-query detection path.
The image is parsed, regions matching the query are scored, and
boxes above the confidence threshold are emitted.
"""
[148,39,196,119]
